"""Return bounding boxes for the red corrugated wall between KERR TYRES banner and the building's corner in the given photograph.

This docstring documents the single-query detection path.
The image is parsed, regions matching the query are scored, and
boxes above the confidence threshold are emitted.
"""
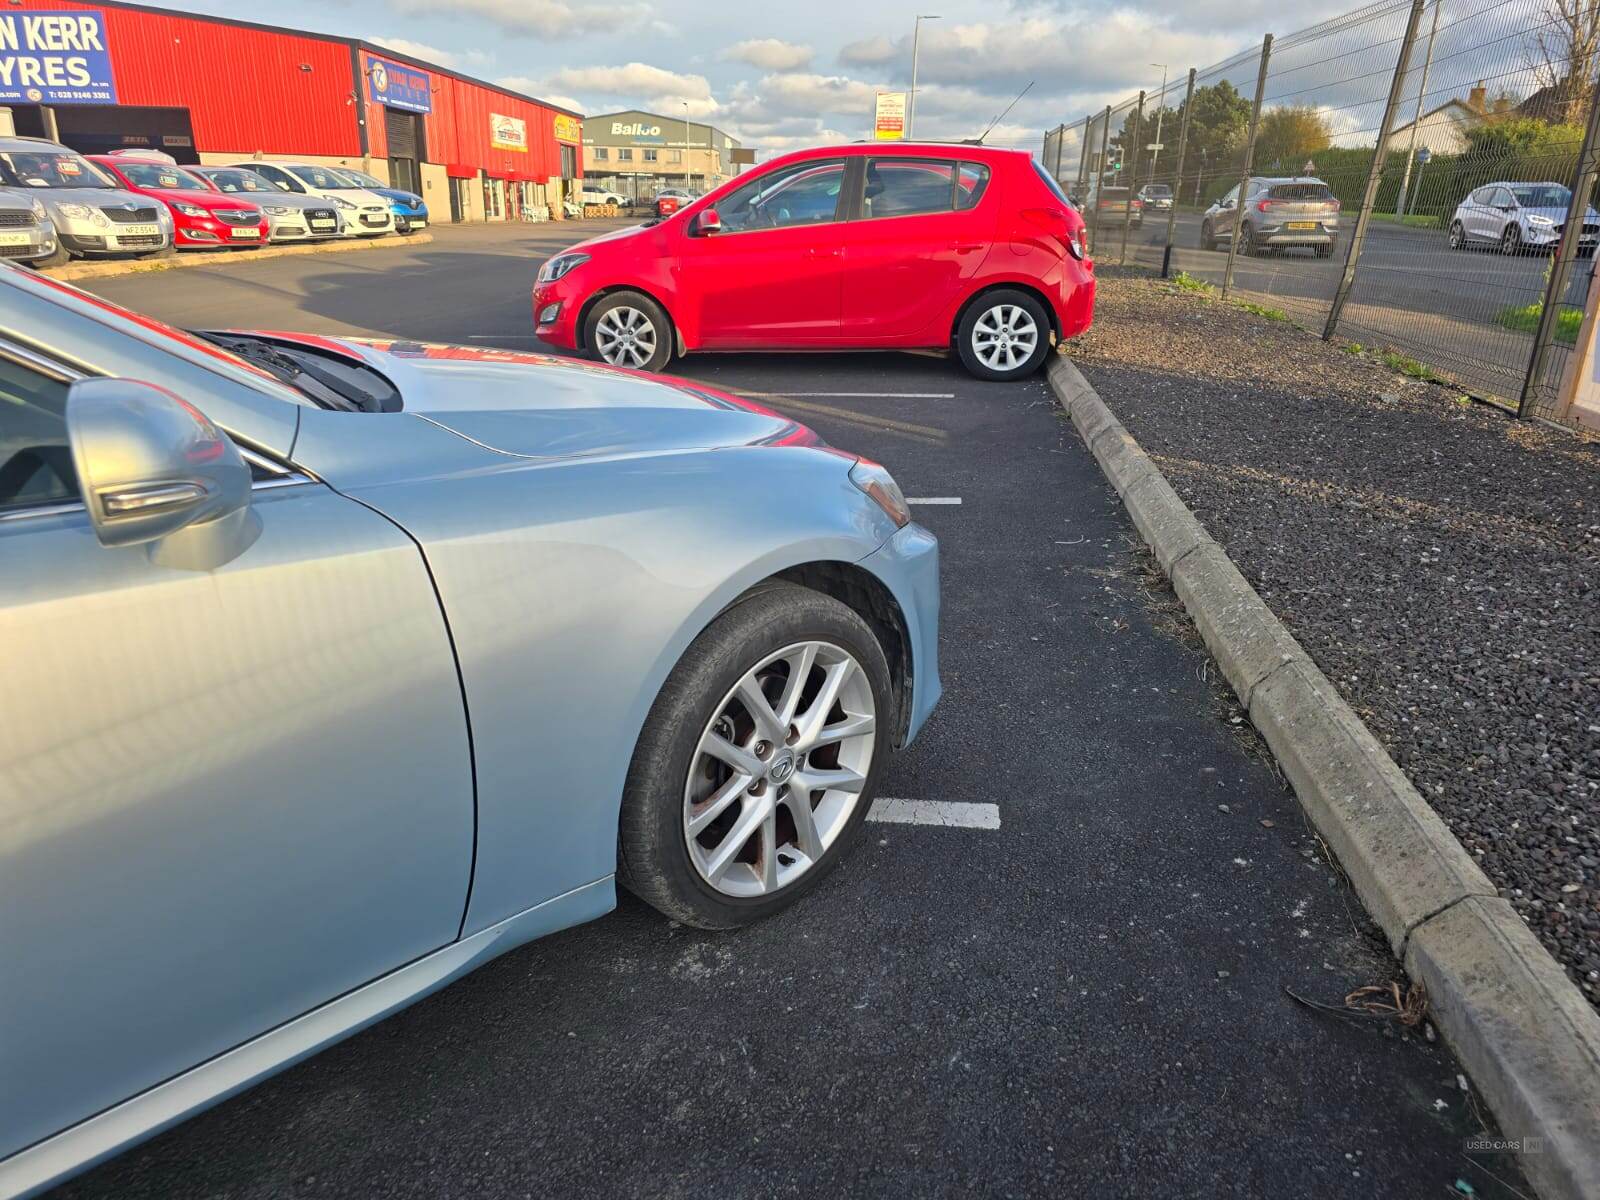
[9,0,362,157]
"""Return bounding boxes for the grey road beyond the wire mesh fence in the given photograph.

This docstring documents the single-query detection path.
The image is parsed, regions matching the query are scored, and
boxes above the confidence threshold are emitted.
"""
[1096,213,1589,398]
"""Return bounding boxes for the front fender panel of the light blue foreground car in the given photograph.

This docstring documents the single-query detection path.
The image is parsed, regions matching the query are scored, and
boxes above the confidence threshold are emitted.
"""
[328,430,894,936]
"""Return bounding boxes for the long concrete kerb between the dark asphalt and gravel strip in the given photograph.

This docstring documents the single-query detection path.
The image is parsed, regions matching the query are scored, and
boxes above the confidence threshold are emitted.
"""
[1050,347,1600,1200]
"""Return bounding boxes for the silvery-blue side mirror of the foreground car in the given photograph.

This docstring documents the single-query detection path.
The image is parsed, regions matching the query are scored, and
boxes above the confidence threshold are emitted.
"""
[67,379,254,565]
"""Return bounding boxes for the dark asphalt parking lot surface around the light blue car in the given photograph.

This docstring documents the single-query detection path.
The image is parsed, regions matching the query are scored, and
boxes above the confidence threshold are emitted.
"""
[58,222,1515,1200]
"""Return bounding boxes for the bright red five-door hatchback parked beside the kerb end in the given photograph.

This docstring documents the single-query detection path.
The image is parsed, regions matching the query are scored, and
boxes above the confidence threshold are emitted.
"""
[533,144,1094,379]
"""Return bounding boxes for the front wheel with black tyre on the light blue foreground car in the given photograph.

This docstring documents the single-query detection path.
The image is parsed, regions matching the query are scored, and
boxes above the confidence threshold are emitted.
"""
[618,582,899,930]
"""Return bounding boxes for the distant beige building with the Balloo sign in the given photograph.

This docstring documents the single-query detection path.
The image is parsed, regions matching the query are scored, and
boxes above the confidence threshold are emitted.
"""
[584,109,742,203]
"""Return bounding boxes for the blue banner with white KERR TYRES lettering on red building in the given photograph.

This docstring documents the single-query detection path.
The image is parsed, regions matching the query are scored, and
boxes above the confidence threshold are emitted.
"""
[0,8,117,104]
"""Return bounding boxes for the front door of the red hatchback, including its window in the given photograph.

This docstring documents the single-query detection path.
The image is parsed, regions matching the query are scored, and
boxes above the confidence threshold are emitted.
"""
[675,158,845,349]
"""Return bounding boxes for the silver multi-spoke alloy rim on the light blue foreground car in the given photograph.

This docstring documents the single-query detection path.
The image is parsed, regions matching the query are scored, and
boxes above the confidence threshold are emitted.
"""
[683,642,877,896]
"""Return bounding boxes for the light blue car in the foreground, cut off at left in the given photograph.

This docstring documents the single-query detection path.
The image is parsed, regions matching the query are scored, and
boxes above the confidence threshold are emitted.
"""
[0,266,939,1197]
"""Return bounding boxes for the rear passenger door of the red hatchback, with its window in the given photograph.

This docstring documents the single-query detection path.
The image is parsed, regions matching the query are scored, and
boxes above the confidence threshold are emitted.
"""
[840,157,998,346]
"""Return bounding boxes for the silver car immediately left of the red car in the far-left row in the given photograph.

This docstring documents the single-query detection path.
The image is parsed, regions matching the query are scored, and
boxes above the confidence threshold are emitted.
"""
[0,138,173,261]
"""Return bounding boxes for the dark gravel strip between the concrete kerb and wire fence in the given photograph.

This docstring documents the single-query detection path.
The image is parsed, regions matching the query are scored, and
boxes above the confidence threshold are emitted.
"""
[1072,270,1600,1006]
